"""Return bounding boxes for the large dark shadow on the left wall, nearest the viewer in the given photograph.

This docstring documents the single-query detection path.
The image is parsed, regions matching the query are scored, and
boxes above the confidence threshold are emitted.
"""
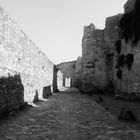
[0,75,24,115]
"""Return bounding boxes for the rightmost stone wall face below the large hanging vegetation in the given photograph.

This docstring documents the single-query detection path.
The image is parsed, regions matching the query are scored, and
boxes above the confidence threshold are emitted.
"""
[116,40,140,93]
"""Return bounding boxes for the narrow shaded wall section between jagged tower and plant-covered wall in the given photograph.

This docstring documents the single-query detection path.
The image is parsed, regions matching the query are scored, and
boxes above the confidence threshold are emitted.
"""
[104,14,122,84]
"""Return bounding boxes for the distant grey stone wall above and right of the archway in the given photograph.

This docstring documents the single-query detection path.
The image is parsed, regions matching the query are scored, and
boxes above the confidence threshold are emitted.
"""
[57,61,76,86]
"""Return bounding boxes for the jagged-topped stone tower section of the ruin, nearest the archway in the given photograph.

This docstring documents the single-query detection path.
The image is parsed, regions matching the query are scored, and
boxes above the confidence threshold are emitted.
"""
[82,24,107,92]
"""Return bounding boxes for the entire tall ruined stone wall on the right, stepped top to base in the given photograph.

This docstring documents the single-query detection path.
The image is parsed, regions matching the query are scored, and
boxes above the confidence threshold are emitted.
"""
[81,0,140,93]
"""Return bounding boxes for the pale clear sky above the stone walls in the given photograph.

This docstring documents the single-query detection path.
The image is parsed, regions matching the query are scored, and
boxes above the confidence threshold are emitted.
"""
[0,0,126,64]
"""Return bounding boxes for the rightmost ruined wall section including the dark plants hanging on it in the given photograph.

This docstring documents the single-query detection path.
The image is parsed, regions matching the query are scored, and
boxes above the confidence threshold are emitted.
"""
[116,0,140,94]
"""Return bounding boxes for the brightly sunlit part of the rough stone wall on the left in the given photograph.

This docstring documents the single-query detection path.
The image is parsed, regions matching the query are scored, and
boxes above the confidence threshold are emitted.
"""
[0,8,53,106]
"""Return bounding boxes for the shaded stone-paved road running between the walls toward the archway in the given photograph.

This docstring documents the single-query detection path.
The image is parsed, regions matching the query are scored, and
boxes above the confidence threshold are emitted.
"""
[0,87,140,140]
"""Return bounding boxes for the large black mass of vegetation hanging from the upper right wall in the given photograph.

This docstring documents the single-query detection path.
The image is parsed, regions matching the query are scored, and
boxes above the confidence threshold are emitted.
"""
[120,0,140,45]
